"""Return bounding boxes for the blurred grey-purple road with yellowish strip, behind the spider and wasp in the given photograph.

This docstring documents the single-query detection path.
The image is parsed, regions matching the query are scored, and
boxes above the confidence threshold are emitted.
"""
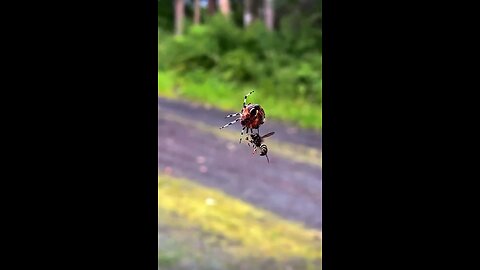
[158,98,322,229]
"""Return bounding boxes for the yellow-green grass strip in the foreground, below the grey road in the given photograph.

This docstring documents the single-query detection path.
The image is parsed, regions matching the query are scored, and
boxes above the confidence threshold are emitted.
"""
[158,175,322,262]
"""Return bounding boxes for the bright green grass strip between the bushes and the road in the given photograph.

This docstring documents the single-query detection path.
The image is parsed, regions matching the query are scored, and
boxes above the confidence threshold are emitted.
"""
[158,71,322,130]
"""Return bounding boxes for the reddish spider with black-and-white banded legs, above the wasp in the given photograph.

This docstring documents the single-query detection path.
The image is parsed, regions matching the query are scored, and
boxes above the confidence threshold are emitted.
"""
[220,91,265,143]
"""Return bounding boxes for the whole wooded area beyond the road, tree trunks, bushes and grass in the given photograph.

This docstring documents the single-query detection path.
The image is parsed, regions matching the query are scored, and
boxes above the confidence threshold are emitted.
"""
[158,0,322,130]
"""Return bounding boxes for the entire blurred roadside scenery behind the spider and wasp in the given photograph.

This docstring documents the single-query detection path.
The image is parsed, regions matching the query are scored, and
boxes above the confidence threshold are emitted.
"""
[158,0,322,269]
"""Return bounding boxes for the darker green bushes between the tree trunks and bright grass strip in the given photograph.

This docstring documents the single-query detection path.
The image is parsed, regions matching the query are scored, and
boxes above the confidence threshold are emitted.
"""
[158,13,322,128]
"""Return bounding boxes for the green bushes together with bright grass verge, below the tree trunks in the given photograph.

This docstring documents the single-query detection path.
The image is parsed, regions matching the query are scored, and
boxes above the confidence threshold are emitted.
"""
[158,3,322,129]
